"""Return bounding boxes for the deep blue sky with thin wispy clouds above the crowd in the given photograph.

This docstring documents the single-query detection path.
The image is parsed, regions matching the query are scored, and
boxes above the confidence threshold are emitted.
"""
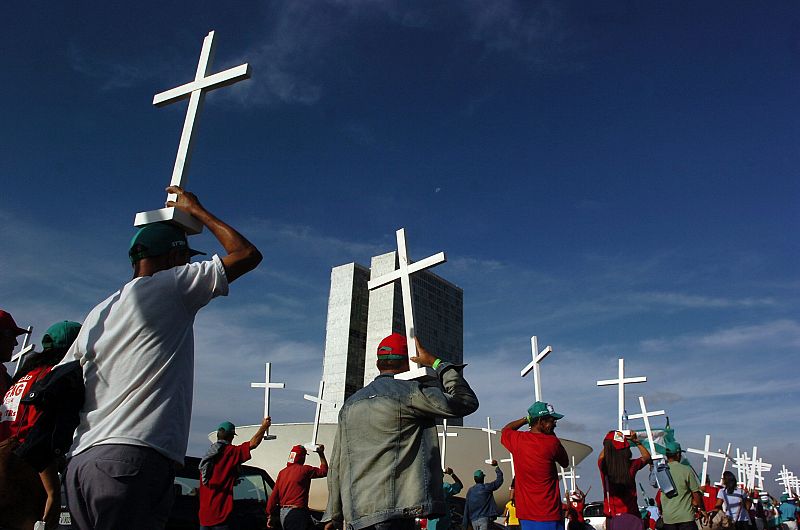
[0,0,800,491]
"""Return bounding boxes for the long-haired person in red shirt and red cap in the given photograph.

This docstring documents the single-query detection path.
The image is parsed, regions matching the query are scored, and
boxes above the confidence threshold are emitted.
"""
[597,431,652,530]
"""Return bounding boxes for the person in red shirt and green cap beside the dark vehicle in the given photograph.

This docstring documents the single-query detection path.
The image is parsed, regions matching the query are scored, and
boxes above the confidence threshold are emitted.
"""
[199,417,272,530]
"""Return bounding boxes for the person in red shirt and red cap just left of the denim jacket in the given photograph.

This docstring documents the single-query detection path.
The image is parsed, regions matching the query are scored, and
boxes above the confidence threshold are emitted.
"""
[267,445,328,530]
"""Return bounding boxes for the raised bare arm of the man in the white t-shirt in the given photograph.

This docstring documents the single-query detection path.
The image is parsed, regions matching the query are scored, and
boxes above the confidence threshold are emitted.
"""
[167,186,262,283]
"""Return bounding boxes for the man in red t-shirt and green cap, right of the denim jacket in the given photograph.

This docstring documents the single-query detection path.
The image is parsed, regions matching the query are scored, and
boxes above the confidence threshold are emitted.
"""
[500,401,569,530]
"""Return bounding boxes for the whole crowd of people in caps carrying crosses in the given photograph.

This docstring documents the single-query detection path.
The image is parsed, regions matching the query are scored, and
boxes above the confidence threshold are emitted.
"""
[0,186,797,530]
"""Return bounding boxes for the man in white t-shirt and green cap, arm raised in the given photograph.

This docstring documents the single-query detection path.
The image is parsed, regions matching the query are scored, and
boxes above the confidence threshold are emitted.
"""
[63,186,261,530]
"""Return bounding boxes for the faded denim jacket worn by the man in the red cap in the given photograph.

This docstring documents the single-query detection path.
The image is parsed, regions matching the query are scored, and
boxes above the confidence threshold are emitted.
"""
[322,362,478,530]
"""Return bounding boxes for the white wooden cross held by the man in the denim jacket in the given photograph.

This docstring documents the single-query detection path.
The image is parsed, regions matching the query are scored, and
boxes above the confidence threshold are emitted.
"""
[367,228,447,379]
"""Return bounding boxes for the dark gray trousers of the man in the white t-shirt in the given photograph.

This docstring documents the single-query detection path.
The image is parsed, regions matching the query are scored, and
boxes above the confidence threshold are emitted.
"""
[65,444,175,530]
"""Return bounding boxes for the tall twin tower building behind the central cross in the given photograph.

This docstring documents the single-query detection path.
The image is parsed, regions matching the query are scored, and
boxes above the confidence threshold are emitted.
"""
[320,252,464,425]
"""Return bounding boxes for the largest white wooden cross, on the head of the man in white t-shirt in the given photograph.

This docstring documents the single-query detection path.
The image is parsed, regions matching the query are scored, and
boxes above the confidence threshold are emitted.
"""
[133,31,250,234]
